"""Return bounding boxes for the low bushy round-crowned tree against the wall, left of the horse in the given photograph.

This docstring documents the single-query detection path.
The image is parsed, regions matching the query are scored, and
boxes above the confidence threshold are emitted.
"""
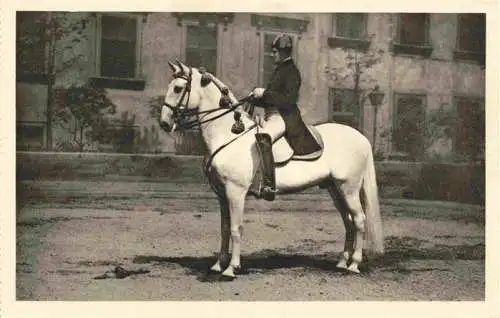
[54,84,116,152]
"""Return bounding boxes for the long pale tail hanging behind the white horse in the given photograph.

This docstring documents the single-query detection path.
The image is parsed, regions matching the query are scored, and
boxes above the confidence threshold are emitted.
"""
[362,149,384,254]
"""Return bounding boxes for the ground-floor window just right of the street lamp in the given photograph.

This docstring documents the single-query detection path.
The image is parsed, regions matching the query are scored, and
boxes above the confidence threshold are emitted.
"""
[392,94,425,160]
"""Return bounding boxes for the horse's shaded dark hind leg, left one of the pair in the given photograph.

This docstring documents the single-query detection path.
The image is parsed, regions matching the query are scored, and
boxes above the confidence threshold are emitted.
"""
[327,182,356,269]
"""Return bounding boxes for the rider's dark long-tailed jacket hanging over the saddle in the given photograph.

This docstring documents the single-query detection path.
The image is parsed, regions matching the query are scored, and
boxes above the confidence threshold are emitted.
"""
[260,59,320,155]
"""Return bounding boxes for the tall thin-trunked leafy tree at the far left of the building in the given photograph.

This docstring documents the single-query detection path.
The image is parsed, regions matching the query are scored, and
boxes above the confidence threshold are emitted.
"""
[16,12,89,150]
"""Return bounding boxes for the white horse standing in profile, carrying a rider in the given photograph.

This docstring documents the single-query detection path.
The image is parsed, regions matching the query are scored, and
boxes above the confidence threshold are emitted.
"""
[159,61,384,279]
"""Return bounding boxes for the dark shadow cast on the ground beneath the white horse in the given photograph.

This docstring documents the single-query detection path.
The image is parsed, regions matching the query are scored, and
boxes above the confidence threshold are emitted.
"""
[133,236,485,281]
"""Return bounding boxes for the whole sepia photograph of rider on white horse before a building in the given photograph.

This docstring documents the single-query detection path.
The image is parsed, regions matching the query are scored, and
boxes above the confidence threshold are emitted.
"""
[2,1,498,317]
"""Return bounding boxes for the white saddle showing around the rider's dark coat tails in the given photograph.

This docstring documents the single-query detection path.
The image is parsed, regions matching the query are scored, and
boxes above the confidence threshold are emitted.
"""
[272,125,324,166]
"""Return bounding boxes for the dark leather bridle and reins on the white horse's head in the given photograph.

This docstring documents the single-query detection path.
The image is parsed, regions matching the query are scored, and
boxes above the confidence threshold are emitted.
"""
[163,67,250,130]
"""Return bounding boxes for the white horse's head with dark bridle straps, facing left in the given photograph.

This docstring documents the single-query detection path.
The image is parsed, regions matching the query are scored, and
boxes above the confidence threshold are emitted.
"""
[160,61,206,132]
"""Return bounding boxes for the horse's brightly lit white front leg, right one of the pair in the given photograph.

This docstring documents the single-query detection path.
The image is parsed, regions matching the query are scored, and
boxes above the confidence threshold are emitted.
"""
[222,183,247,279]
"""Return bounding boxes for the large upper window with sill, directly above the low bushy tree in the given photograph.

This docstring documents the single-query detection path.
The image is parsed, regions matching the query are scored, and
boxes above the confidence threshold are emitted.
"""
[94,13,144,90]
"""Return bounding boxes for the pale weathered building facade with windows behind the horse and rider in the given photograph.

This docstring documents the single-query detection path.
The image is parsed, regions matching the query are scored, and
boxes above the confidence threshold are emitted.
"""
[16,12,485,160]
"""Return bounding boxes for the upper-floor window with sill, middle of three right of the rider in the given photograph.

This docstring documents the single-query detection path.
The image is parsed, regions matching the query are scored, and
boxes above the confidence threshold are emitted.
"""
[394,13,432,56]
